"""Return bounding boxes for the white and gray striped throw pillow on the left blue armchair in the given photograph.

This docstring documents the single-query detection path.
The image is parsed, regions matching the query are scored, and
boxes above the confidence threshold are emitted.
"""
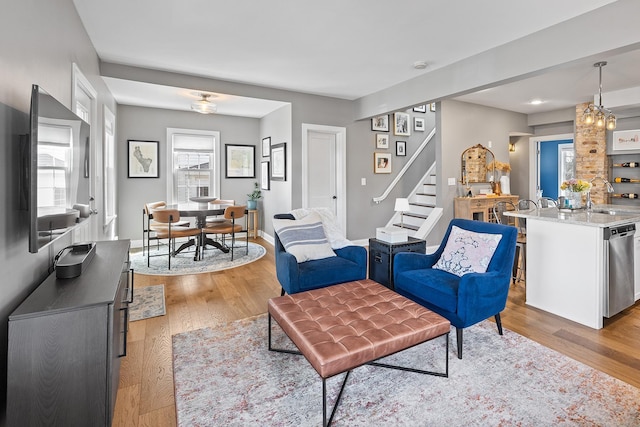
[273,212,336,263]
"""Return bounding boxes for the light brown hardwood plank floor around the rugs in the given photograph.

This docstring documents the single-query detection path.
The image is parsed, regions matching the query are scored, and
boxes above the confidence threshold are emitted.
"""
[113,239,640,427]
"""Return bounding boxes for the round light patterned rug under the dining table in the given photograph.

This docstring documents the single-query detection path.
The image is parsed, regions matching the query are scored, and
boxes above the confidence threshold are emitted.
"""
[131,242,267,276]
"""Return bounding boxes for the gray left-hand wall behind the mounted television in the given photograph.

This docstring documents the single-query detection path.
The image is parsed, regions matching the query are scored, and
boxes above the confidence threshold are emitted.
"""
[0,0,115,425]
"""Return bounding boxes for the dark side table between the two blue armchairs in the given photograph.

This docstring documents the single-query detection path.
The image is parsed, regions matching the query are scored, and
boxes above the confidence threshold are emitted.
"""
[369,237,427,289]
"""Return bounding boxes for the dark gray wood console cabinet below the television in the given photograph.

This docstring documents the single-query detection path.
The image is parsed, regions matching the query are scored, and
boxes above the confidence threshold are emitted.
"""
[7,240,133,427]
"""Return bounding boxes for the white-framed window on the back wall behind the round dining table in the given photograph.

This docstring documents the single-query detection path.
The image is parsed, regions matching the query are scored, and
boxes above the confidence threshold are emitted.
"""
[167,129,220,203]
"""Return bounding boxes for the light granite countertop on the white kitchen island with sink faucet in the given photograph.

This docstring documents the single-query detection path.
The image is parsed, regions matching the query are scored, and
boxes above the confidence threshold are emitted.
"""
[504,205,640,228]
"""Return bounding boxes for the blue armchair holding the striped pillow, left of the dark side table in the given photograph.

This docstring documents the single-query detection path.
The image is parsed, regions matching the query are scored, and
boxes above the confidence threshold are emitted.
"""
[274,214,367,295]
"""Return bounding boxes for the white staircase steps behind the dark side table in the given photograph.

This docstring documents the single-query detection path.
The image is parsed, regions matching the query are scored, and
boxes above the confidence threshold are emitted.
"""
[387,164,442,239]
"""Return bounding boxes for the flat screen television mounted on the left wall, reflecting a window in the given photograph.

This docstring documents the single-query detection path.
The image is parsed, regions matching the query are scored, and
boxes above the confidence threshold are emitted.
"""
[22,85,90,253]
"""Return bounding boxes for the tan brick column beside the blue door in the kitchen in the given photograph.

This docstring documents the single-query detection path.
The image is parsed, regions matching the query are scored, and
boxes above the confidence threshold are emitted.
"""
[574,102,609,203]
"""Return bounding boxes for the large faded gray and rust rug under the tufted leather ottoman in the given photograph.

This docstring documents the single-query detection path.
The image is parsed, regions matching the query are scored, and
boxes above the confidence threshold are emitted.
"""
[173,315,640,427]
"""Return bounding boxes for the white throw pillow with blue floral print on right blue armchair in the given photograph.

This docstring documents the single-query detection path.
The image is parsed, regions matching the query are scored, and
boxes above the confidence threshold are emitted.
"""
[433,225,502,276]
